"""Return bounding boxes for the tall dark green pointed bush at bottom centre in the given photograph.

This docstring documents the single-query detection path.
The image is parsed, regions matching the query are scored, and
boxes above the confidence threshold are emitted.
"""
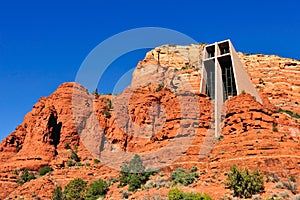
[120,154,154,191]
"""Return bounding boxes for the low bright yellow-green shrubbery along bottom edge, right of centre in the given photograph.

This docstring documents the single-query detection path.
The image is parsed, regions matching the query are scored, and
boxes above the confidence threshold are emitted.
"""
[168,188,212,200]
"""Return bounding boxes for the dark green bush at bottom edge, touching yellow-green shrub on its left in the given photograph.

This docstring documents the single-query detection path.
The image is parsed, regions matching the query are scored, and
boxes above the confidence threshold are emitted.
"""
[86,179,109,200]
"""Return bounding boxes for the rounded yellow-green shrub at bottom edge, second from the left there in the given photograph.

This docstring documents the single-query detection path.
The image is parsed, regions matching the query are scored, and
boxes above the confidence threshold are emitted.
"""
[63,178,87,200]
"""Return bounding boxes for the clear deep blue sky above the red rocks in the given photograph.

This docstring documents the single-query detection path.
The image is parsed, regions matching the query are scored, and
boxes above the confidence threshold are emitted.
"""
[0,0,300,140]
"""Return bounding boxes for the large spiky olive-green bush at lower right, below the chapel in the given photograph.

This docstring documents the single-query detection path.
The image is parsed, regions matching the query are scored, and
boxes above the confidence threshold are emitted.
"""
[225,165,264,198]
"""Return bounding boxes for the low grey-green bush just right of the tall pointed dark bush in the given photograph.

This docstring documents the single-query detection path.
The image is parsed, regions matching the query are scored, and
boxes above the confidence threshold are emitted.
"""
[171,168,199,186]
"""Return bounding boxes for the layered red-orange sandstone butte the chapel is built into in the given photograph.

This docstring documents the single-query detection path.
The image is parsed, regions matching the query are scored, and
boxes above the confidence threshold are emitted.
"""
[0,44,300,199]
